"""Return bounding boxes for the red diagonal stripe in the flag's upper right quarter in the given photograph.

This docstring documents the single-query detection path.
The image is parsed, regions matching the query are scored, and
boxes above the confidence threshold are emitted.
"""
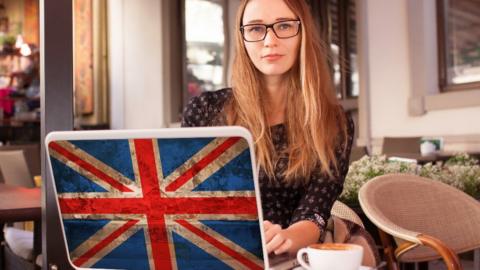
[165,137,240,191]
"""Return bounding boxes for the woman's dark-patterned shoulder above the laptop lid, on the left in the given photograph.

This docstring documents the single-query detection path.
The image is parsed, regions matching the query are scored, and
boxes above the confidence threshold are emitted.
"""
[182,88,232,126]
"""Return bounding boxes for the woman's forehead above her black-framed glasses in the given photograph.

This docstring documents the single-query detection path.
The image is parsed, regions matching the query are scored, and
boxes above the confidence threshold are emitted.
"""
[242,0,296,24]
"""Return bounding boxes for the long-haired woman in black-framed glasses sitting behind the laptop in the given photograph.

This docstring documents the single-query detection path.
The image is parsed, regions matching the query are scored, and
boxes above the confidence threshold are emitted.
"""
[182,0,354,254]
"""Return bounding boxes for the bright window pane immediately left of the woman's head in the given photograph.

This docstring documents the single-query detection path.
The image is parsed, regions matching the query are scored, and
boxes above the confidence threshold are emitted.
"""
[183,0,226,107]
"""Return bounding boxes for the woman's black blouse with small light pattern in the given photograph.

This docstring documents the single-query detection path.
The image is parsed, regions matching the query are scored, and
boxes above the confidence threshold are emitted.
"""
[182,89,354,232]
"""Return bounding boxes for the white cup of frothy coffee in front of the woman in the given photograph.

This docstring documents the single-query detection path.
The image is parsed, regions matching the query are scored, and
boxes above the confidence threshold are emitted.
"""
[297,243,363,270]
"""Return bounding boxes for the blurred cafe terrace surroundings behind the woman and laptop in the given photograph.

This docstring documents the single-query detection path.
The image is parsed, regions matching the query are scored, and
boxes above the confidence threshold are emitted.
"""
[0,0,480,270]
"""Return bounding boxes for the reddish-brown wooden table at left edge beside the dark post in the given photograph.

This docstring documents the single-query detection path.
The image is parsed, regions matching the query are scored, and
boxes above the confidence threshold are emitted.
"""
[0,183,42,264]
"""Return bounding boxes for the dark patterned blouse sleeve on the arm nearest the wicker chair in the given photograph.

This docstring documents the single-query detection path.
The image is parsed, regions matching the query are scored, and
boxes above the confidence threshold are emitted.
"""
[290,115,355,234]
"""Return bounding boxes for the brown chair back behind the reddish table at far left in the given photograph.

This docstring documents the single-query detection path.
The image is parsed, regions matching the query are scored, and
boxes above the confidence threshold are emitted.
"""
[0,150,35,188]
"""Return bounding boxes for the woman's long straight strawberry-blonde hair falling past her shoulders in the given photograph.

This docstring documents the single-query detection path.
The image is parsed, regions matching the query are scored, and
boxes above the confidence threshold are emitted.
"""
[225,0,347,182]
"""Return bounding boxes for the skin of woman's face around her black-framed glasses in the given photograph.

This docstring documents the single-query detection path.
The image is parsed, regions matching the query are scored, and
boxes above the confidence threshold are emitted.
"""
[242,0,301,81]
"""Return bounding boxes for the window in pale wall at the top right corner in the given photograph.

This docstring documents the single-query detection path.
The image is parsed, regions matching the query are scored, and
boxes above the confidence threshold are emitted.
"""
[437,0,480,92]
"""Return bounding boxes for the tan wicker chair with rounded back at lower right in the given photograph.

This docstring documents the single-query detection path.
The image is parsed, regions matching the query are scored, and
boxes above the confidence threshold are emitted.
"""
[359,174,480,270]
